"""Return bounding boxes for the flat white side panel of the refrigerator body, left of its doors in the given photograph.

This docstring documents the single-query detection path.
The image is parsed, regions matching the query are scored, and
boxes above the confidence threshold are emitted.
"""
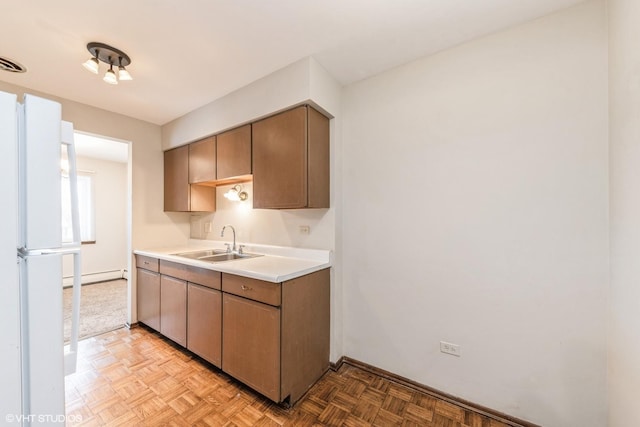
[0,92,23,422]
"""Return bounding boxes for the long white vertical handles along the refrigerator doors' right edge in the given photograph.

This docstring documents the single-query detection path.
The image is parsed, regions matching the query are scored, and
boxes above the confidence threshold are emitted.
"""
[62,122,82,375]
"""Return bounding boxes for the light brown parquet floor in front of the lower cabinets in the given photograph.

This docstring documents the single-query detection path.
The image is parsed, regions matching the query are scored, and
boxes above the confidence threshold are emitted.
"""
[66,327,508,427]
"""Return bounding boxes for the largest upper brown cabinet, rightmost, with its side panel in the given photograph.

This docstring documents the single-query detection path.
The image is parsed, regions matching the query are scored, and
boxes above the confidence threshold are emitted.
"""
[253,105,329,209]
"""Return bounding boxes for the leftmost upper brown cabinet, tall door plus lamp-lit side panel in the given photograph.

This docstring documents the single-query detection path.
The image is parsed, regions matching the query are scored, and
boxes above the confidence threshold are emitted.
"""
[164,144,216,212]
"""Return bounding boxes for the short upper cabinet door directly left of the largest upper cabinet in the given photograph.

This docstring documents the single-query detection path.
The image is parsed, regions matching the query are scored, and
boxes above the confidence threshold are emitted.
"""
[217,125,251,179]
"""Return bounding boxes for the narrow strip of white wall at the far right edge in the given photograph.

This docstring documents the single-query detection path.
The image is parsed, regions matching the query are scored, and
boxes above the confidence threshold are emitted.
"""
[608,0,640,427]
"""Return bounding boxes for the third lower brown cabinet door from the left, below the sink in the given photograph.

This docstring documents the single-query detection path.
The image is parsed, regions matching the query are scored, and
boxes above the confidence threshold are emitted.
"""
[187,283,222,368]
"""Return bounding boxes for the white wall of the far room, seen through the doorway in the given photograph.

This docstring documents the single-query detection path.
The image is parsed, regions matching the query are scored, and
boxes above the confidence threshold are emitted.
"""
[63,157,129,283]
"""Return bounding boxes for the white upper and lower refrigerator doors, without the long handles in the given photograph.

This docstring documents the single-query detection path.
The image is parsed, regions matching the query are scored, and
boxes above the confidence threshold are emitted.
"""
[14,95,80,422]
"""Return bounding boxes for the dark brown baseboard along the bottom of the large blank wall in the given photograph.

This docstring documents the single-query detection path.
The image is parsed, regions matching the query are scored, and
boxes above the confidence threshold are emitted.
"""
[338,356,540,427]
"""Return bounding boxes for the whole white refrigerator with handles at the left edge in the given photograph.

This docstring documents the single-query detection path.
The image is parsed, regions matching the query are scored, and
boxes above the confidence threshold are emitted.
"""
[0,92,81,426]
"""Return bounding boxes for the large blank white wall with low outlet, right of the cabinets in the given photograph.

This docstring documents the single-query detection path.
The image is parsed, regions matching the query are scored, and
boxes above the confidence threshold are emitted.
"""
[342,1,608,427]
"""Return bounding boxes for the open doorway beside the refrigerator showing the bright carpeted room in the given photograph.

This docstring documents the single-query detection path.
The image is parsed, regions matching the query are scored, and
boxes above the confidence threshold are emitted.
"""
[63,131,132,342]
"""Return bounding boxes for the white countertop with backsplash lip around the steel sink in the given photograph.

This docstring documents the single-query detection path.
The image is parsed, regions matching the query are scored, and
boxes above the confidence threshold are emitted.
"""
[133,239,332,283]
